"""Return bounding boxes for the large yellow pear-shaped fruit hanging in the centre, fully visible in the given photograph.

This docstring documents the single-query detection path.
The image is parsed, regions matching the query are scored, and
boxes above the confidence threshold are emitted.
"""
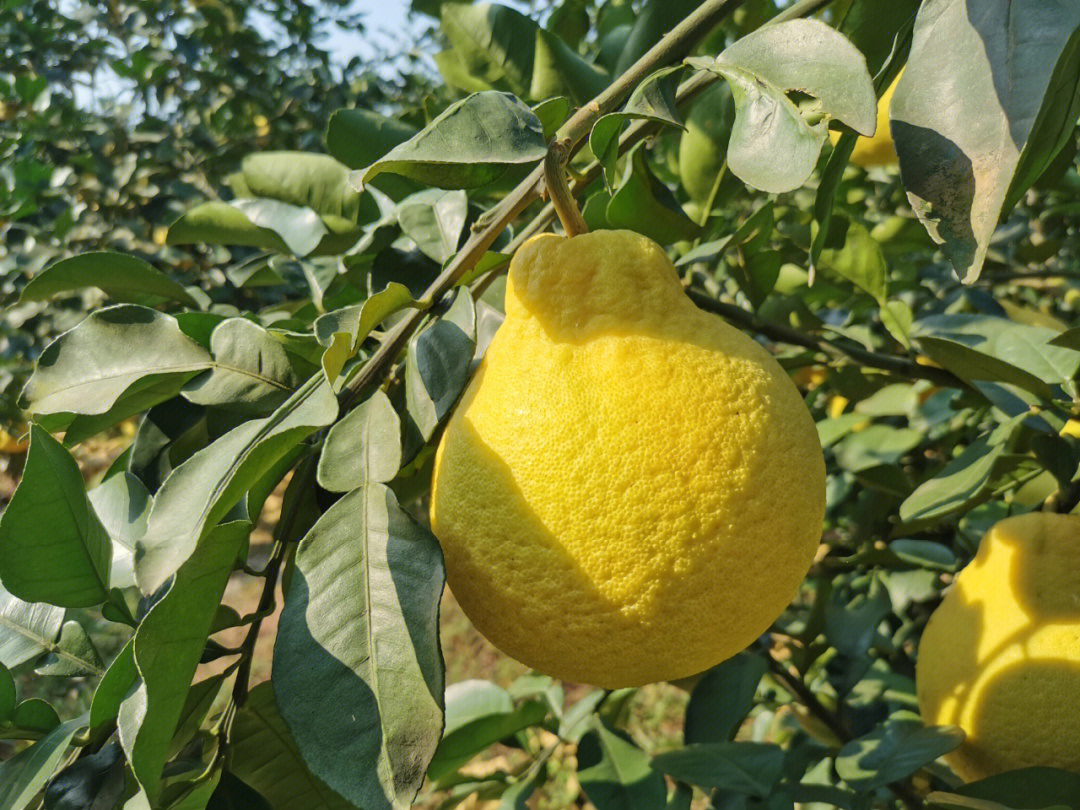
[431,231,825,688]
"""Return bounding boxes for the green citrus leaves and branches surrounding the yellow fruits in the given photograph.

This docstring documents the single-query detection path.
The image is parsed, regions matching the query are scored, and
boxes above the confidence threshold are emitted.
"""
[0,0,1080,810]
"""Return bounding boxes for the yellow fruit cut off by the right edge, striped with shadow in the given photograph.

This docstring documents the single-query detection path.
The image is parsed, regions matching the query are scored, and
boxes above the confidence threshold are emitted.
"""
[916,512,1080,781]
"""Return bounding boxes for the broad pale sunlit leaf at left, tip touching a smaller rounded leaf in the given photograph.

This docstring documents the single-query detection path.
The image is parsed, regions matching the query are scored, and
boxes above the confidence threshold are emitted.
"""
[19,305,211,432]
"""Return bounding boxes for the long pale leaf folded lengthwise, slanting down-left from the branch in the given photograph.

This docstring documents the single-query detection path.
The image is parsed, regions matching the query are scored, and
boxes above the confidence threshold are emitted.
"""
[135,374,338,593]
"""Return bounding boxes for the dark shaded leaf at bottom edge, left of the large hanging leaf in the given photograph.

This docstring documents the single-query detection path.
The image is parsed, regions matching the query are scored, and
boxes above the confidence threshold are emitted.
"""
[230,683,352,810]
